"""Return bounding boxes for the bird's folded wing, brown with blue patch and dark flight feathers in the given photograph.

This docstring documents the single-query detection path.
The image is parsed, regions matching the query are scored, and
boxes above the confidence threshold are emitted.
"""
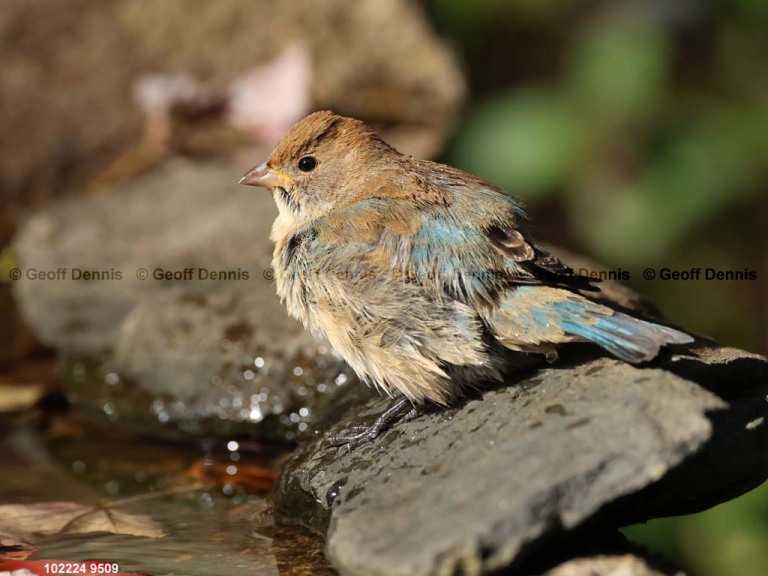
[317,190,584,316]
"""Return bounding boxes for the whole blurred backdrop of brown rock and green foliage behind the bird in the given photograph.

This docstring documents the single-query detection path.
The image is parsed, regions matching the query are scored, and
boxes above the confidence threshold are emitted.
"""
[0,0,768,576]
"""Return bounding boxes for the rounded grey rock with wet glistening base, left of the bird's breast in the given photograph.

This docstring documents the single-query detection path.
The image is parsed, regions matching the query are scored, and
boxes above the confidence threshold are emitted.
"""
[14,161,360,439]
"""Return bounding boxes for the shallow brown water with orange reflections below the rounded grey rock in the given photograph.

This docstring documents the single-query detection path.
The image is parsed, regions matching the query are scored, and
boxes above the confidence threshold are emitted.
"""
[0,414,335,576]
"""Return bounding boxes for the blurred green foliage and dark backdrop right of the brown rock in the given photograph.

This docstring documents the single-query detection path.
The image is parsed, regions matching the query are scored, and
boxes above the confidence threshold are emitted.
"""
[436,0,768,576]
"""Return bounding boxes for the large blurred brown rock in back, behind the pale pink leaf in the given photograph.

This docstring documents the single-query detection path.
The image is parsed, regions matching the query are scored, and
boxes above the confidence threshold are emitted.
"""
[0,0,466,212]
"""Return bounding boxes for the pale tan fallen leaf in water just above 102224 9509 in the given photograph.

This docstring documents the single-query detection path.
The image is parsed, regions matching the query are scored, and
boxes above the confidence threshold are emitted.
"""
[0,502,165,546]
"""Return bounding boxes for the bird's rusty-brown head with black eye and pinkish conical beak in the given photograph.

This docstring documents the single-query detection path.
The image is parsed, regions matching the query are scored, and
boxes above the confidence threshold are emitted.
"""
[240,111,400,223]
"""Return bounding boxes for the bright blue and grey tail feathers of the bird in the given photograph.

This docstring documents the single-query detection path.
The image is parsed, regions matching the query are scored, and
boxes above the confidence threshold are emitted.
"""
[559,306,693,363]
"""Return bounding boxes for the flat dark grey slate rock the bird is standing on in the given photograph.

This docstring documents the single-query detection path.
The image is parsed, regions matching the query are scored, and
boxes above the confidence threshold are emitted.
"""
[276,343,768,576]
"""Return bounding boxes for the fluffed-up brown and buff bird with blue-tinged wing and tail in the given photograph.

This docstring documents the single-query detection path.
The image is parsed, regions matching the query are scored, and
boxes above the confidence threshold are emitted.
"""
[240,111,693,447]
